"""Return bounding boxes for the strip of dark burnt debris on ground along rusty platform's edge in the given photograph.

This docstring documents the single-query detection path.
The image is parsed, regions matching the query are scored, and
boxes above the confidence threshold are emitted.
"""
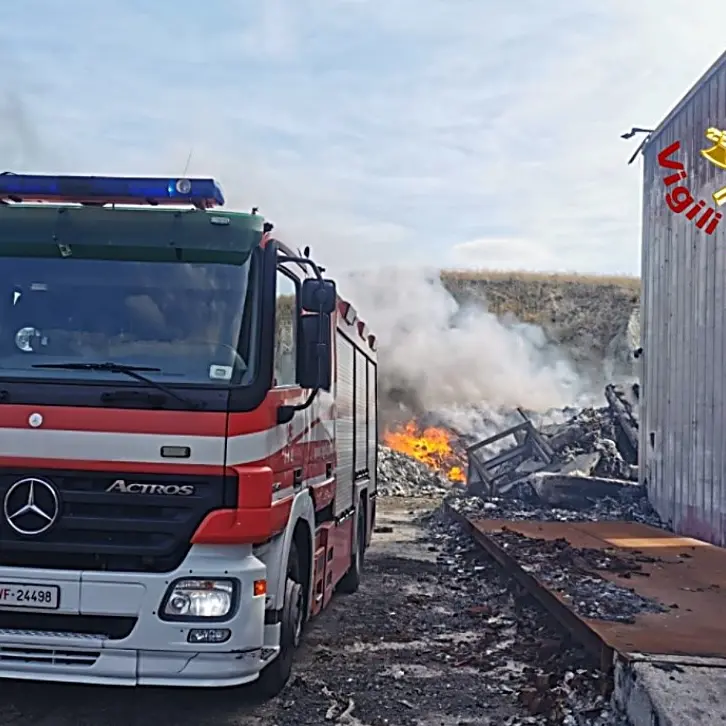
[426,511,625,726]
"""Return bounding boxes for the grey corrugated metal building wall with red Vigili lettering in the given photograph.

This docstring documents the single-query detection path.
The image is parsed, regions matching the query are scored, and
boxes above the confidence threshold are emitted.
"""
[640,57,726,545]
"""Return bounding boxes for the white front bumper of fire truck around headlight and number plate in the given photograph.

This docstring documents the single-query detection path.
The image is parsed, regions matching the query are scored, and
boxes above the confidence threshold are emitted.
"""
[0,545,279,687]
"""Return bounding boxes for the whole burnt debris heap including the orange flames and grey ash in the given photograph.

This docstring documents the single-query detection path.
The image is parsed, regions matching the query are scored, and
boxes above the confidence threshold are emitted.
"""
[378,384,663,527]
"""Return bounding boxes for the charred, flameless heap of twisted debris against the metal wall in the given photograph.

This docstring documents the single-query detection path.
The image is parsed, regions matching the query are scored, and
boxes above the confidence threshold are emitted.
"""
[450,384,663,527]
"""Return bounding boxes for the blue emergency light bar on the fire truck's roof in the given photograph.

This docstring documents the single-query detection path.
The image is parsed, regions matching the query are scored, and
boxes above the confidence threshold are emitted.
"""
[0,173,224,209]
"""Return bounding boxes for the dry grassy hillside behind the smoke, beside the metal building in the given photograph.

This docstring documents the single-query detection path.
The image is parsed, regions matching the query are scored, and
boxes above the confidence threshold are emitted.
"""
[441,270,640,361]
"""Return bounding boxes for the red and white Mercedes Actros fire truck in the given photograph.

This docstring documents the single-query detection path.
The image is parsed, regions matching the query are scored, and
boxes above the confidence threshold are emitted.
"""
[0,173,378,696]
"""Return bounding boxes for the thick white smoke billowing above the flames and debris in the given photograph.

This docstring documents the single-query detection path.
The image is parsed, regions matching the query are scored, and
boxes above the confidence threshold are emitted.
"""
[340,269,602,436]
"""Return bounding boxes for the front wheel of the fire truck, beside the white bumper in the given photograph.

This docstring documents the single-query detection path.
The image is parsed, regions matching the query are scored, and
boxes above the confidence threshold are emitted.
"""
[257,544,305,698]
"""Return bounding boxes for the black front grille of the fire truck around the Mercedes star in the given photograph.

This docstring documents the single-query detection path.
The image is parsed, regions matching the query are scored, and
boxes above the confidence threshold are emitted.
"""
[0,469,236,572]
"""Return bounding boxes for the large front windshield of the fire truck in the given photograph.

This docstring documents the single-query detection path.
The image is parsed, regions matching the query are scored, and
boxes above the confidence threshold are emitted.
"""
[0,257,252,384]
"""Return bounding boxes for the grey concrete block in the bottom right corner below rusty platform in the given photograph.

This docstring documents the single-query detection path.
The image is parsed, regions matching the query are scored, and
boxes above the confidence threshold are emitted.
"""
[613,658,726,726]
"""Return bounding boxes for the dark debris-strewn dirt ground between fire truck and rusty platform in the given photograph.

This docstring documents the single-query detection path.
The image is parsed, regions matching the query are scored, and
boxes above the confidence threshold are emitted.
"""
[0,499,610,726]
